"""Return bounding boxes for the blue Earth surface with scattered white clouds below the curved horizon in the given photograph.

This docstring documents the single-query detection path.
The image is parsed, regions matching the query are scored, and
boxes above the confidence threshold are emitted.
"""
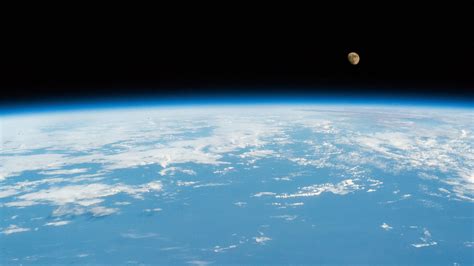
[0,104,474,265]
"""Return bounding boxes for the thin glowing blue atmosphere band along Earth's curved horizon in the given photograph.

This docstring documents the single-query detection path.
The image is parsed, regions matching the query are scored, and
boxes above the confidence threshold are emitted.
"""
[0,94,474,115]
